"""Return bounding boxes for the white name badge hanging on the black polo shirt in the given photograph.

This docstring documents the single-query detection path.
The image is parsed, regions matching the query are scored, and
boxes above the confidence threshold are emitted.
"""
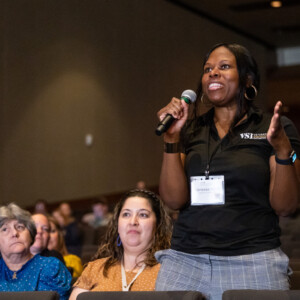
[191,175,225,205]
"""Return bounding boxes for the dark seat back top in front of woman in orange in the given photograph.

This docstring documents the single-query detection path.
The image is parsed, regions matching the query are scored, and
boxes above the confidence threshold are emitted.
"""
[76,291,205,300]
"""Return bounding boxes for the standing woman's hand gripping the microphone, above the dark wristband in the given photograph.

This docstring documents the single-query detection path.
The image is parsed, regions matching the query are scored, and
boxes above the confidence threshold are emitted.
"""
[157,97,189,143]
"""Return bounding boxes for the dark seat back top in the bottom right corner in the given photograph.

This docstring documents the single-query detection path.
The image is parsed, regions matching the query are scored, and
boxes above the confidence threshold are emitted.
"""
[222,290,300,300]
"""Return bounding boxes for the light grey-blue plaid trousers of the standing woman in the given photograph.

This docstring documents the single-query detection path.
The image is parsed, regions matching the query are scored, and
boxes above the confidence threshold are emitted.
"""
[155,248,291,300]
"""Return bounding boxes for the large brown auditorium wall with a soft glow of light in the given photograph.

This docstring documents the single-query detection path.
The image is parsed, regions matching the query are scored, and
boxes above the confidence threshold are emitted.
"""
[0,0,270,205]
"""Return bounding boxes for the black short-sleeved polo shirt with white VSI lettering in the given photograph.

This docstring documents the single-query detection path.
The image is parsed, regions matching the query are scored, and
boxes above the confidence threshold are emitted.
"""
[171,108,300,255]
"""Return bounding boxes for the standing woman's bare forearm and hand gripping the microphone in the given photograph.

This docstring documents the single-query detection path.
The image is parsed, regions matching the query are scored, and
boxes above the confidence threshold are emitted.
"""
[157,98,188,210]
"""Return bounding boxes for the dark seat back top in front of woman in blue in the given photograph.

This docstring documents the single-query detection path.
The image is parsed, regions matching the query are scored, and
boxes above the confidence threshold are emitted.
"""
[0,291,59,300]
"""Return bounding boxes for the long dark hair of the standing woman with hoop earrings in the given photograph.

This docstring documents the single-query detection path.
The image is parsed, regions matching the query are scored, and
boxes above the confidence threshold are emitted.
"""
[193,43,260,129]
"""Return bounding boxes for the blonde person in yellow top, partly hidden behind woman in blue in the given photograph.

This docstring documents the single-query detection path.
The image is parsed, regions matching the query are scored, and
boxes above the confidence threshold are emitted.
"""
[48,217,82,278]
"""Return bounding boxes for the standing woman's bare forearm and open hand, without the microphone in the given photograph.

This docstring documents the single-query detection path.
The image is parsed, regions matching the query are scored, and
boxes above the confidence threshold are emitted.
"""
[267,101,300,216]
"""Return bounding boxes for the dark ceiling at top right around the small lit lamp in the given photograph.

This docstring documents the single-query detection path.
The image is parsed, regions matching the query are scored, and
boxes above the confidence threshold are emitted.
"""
[167,0,300,49]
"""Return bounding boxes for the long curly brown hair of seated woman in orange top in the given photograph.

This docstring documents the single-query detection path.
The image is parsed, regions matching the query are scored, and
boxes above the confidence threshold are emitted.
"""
[92,189,172,277]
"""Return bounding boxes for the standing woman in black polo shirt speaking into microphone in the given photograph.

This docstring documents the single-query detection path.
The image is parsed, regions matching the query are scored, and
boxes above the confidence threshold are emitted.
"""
[156,44,300,300]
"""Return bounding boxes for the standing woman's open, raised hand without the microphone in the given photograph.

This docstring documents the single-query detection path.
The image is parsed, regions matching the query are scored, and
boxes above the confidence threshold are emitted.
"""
[267,101,292,159]
